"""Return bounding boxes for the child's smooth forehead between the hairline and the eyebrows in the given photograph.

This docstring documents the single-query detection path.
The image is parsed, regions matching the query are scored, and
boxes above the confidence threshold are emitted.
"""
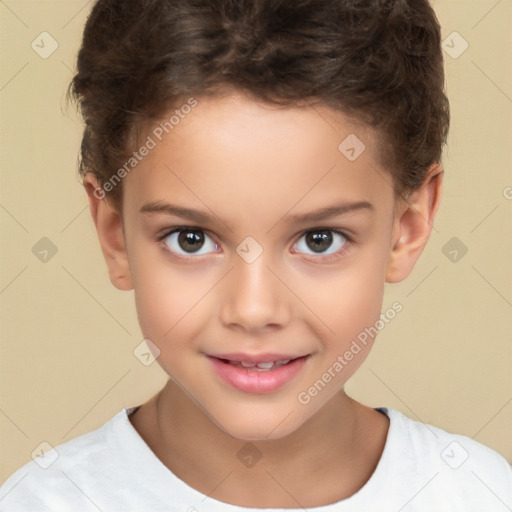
[125,93,392,219]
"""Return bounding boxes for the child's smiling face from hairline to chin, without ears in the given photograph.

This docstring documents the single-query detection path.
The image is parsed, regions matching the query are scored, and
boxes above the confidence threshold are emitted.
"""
[116,93,404,440]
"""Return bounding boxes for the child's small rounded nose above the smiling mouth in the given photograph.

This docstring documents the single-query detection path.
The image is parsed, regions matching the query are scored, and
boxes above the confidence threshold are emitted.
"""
[221,251,291,332]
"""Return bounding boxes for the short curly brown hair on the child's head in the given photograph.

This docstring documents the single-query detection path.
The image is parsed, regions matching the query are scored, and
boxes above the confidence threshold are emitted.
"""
[68,0,450,208]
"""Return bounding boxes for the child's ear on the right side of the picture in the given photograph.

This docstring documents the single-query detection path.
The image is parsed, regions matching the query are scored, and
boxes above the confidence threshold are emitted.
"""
[386,164,444,283]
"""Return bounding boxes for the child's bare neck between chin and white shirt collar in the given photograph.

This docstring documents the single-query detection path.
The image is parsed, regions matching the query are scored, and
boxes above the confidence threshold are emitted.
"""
[132,380,387,508]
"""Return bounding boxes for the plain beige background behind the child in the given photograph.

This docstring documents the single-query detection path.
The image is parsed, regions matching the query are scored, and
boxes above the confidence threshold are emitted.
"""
[0,0,512,481]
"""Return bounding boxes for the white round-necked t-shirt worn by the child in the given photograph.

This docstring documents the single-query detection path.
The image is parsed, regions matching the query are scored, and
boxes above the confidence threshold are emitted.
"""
[0,407,512,512]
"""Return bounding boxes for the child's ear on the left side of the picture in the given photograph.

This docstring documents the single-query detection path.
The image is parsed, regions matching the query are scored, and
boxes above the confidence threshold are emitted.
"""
[83,173,133,291]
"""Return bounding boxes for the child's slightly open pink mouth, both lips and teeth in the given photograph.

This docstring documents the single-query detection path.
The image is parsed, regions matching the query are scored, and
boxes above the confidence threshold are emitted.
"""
[207,354,311,393]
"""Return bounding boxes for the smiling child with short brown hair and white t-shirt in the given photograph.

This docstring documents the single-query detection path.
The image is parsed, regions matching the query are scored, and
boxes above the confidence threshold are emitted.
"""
[0,0,512,512]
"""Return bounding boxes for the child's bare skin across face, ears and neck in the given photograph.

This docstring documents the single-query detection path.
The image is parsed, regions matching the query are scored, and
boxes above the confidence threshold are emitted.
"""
[84,92,443,508]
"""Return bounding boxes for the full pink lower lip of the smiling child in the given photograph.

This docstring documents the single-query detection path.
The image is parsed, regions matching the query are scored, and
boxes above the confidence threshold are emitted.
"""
[207,356,309,393]
